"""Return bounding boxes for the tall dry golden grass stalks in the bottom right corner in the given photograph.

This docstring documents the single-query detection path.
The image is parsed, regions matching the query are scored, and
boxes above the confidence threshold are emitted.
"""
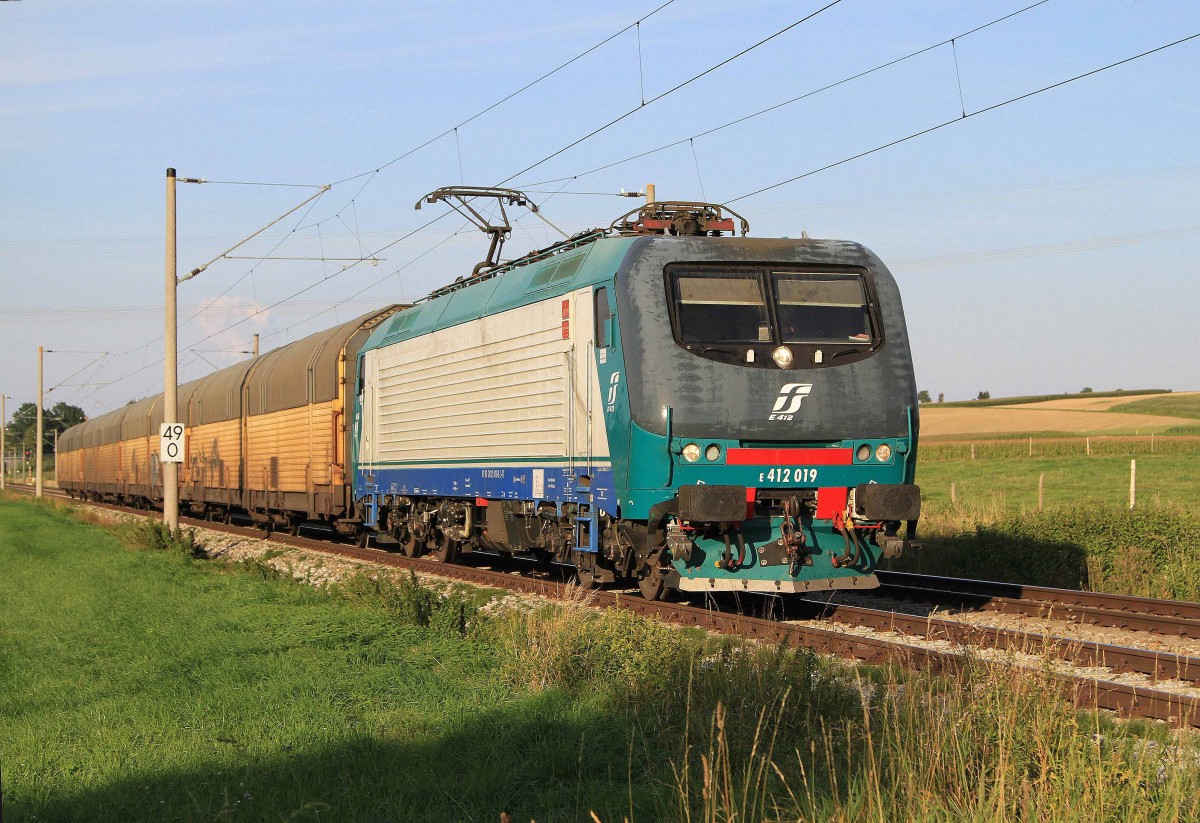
[673,662,1200,823]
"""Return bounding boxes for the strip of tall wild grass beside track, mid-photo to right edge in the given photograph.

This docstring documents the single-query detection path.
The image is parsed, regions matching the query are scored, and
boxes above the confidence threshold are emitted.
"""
[497,602,1200,823]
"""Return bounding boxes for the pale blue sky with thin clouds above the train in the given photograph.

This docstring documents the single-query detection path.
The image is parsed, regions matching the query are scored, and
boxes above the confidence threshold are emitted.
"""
[0,0,1200,415]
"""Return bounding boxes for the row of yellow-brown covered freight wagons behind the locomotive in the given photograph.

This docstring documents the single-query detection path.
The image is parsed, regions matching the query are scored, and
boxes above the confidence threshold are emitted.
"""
[58,305,406,531]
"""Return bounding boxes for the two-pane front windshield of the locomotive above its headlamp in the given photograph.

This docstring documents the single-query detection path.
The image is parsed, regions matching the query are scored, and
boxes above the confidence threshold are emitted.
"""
[667,266,878,347]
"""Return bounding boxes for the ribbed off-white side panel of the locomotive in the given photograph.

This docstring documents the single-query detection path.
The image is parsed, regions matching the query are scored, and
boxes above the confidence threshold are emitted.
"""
[362,289,608,463]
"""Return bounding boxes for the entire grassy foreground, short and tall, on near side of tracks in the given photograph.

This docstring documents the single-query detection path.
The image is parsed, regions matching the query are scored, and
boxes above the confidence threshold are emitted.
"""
[0,499,1200,823]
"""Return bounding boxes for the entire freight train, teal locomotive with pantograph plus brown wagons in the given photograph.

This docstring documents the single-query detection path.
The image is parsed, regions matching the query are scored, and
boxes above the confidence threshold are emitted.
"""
[59,188,920,599]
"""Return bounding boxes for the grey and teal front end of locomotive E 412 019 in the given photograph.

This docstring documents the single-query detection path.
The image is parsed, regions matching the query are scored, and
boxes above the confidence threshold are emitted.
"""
[613,229,920,593]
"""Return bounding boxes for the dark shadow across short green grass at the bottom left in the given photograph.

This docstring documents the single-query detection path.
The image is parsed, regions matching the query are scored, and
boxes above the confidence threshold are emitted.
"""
[14,692,667,823]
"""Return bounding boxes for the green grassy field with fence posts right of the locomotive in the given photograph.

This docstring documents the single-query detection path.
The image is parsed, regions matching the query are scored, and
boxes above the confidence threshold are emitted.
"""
[893,395,1200,600]
